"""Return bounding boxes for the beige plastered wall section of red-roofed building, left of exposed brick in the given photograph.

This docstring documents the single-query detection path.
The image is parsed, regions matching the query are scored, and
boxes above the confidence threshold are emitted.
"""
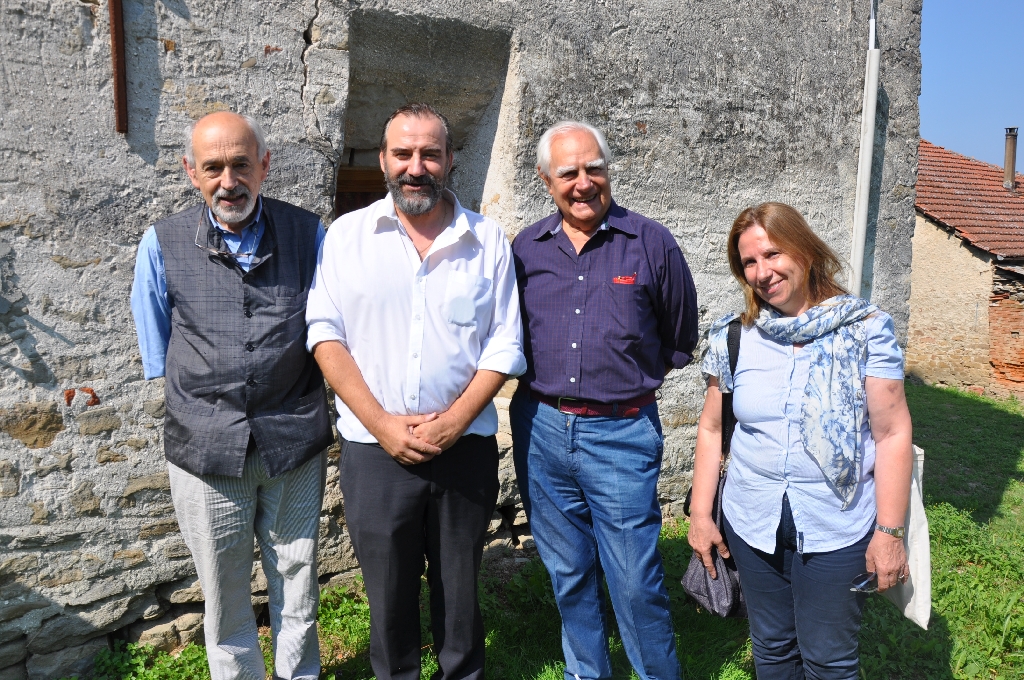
[906,215,992,389]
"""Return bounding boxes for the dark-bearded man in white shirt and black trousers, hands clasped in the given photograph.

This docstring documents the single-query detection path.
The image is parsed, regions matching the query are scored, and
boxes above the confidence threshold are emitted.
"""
[306,103,526,680]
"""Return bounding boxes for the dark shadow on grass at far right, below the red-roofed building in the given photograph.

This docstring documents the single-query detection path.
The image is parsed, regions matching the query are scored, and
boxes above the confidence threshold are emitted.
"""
[906,383,1024,523]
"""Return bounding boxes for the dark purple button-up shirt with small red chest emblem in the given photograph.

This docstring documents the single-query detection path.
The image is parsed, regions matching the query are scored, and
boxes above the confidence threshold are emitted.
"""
[512,203,697,403]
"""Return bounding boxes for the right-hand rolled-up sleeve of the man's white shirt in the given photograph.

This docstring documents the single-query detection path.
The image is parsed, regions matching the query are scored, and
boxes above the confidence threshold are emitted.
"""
[476,237,526,377]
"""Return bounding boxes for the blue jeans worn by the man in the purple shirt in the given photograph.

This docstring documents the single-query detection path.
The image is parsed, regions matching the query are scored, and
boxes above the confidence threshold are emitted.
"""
[509,391,679,680]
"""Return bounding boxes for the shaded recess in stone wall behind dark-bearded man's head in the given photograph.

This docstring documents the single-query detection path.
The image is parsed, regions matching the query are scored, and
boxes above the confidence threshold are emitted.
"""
[342,11,509,210]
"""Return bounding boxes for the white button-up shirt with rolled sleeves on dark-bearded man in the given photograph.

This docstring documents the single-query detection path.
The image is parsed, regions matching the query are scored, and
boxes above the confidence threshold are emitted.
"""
[306,192,526,443]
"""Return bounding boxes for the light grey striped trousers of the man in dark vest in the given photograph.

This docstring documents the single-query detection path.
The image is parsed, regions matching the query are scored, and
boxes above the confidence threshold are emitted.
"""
[167,451,327,680]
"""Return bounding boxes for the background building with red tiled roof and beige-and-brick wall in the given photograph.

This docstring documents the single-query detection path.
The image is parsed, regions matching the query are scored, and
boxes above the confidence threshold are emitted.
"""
[906,139,1024,394]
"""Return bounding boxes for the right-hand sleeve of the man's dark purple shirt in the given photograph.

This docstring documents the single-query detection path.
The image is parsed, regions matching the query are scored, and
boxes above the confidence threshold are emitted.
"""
[657,246,697,369]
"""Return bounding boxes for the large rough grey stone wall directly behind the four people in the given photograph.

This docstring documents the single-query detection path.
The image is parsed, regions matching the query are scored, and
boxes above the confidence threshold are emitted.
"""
[0,0,921,680]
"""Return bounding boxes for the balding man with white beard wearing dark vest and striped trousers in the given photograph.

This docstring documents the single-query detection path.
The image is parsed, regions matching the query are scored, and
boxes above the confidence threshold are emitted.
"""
[131,112,332,680]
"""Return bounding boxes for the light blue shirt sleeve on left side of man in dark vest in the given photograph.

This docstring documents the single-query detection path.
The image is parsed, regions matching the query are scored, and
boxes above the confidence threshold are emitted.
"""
[131,226,171,380]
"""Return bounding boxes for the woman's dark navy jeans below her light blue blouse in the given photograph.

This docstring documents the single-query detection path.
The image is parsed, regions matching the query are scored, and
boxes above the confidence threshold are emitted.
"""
[725,496,873,680]
